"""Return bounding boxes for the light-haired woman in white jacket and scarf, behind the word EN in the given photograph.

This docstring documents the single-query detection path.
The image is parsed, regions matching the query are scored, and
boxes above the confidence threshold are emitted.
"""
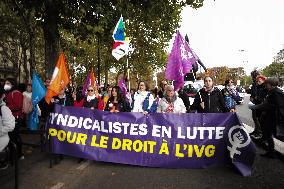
[157,85,186,113]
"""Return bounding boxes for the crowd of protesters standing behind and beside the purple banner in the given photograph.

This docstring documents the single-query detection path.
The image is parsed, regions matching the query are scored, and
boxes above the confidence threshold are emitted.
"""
[0,72,284,170]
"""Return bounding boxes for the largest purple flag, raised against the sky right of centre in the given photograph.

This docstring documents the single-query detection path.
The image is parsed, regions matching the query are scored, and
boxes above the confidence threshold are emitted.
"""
[166,31,197,91]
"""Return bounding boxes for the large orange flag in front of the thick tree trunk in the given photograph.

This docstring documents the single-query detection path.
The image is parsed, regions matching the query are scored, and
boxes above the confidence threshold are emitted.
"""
[45,52,70,104]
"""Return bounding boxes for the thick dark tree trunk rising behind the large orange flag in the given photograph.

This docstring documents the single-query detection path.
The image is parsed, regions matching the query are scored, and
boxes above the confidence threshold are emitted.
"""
[43,0,60,79]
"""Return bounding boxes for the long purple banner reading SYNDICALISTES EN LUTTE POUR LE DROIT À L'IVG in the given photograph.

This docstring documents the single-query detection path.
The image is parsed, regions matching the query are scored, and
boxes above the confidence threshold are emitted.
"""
[47,105,255,176]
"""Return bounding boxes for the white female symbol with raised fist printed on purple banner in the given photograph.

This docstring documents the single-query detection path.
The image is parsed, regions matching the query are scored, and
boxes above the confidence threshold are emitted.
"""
[227,126,251,159]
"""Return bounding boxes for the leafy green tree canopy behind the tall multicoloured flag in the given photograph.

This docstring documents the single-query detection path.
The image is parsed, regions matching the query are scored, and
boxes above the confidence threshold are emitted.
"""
[0,0,203,85]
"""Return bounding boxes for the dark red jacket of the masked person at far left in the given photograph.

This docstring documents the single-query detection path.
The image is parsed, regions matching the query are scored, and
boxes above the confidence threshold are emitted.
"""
[5,90,25,119]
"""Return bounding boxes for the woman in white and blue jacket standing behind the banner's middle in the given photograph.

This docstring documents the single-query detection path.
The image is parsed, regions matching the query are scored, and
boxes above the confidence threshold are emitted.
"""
[132,81,154,115]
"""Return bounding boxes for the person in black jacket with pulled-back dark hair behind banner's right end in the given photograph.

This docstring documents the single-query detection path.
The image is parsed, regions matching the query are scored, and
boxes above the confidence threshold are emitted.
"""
[190,76,231,113]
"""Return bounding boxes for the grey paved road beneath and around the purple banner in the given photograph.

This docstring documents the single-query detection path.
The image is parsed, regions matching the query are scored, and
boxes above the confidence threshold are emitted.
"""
[0,95,284,189]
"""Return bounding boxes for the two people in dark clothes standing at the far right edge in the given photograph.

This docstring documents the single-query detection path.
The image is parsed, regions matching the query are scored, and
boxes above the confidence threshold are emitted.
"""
[249,71,284,158]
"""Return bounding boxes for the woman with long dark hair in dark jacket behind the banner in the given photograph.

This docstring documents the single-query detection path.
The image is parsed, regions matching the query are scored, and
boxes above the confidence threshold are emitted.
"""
[105,86,131,112]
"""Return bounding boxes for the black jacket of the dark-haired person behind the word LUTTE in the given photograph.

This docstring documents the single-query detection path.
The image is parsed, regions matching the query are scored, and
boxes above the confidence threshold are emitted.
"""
[191,87,229,113]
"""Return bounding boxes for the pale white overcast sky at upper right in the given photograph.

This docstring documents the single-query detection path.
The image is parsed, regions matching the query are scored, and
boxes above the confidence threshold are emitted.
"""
[180,0,284,74]
